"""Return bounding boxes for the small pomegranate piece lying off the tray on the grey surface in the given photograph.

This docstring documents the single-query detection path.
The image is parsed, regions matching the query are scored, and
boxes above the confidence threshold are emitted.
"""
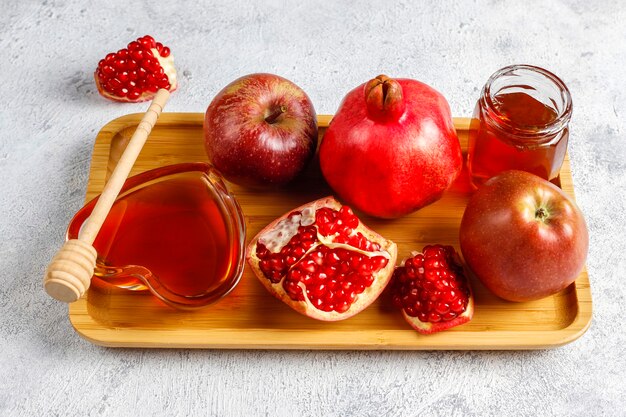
[94,35,178,103]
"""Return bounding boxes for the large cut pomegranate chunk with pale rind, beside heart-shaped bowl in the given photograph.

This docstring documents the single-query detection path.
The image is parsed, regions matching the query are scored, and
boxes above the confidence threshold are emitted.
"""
[248,197,397,321]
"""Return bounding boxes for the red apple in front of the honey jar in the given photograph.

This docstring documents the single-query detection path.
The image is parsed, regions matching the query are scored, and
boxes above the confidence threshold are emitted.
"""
[460,171,589,301]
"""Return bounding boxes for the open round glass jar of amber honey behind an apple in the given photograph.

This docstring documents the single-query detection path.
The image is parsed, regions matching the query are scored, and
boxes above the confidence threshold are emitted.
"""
[468,65,572,187]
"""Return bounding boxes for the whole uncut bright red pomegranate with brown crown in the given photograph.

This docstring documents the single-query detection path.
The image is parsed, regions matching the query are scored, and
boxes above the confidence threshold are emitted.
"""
[319,75,462,218]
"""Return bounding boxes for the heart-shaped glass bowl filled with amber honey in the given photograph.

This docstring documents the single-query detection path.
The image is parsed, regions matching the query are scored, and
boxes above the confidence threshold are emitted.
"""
[67,162,246,309]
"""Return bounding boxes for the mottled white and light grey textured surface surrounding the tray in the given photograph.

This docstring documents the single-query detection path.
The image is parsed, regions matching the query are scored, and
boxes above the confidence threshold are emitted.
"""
[0,0,626,416]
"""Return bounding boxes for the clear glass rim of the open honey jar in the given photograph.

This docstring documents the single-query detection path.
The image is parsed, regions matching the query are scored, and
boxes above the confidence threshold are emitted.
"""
[482,64,572,136]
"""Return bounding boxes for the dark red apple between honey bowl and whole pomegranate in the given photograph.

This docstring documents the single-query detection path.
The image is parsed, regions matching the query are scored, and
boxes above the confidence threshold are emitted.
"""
[204,74,317,187]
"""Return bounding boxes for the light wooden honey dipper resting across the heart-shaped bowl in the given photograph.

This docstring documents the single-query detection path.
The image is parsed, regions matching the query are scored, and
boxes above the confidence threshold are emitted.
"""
[43,89,170,303]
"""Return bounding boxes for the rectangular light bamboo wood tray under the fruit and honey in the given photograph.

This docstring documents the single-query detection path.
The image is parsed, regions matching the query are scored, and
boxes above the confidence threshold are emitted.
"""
[69,113,591,350]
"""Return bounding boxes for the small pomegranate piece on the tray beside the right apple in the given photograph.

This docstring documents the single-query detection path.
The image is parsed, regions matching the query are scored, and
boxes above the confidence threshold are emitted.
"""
[391,245,474,334]
